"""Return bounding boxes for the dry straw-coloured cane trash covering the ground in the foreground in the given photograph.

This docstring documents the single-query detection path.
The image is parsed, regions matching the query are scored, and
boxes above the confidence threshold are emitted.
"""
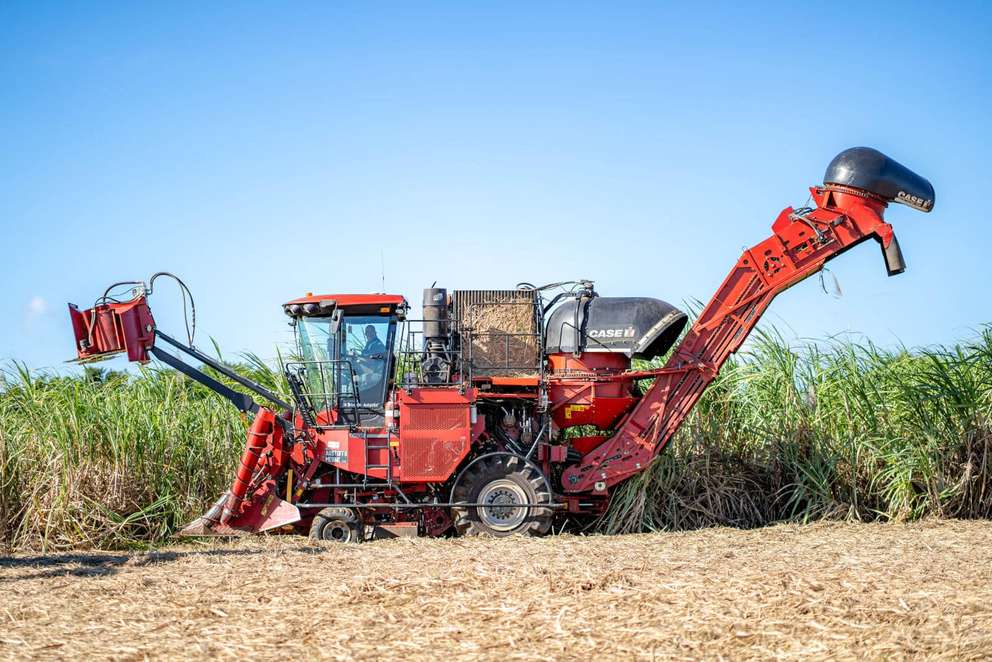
[0,521,992,660]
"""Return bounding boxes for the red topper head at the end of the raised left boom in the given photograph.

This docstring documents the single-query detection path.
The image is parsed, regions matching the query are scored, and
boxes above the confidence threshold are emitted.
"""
[69,295,155,363]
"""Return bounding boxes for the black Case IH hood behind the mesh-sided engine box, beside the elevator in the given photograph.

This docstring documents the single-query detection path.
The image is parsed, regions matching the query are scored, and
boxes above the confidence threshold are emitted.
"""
[545,296,688,359]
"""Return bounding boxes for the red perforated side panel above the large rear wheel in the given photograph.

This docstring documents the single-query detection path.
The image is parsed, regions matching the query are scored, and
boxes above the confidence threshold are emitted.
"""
[396,388,473,482]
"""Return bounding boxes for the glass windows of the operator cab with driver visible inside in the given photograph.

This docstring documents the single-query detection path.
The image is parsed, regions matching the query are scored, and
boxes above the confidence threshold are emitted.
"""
[297,315,393,409]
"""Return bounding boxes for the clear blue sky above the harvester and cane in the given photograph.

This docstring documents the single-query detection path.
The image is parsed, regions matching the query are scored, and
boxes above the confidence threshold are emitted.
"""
[0,2,992,367]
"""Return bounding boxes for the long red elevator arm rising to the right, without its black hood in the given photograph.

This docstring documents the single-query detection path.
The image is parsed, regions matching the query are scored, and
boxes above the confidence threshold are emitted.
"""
[562,187,905,494]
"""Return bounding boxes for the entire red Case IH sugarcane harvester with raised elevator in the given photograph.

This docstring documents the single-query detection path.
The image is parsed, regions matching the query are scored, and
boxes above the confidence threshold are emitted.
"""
[70,147,934,541]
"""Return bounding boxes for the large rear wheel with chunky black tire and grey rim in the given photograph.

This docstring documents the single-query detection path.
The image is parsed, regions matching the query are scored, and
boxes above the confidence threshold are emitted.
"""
[451,453,554,538]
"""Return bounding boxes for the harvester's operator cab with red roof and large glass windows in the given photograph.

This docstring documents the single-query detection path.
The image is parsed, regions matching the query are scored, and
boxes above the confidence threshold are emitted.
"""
[283,294,406,427]
